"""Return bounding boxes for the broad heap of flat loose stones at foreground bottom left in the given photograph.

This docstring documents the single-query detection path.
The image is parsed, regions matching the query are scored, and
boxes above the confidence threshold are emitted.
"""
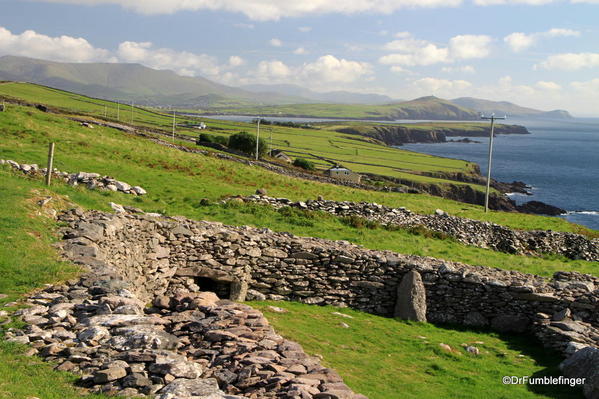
[7,214,365,399]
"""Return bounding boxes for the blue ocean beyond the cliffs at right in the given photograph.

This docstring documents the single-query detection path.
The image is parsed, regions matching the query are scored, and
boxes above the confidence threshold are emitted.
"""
[401,118,599,230]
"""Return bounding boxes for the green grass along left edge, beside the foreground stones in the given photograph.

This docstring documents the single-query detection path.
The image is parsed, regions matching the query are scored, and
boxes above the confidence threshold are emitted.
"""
[0,173,112,399]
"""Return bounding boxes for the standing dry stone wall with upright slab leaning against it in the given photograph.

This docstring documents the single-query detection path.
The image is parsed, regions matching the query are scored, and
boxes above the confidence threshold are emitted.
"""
[59,208,599,358]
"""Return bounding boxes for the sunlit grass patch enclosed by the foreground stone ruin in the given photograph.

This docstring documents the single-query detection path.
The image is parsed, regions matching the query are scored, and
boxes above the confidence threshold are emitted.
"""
[250,302,582,399]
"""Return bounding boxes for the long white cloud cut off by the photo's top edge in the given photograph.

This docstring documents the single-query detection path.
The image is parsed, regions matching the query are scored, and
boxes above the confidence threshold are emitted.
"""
[38,0,463,21]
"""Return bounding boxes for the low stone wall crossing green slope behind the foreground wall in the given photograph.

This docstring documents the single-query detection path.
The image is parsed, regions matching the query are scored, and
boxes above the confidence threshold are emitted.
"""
[233,195,599,262]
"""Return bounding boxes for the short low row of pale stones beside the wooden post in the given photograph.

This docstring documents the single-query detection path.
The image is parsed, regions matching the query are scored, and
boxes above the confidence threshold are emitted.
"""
[0,159,147,195]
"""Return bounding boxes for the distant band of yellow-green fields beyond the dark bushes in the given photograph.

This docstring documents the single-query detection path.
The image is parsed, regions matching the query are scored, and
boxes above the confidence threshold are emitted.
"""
[0,83,492,190]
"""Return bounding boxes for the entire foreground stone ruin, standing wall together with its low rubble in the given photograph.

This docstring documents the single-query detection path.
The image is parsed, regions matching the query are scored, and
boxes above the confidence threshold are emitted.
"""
[7,206,599,399]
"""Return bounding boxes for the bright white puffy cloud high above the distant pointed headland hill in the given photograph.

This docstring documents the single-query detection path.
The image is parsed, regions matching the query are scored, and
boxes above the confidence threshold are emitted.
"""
[379,32,492,66]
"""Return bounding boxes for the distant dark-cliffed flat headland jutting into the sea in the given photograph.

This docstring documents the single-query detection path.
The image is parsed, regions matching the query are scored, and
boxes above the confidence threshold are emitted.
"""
[338,124,530,146]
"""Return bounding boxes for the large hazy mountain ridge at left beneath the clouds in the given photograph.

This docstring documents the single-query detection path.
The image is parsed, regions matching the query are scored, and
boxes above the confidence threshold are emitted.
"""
[0,56,299,107]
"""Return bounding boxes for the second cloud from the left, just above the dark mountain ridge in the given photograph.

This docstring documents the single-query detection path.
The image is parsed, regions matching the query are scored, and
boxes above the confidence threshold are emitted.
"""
[117,42,220,78]
